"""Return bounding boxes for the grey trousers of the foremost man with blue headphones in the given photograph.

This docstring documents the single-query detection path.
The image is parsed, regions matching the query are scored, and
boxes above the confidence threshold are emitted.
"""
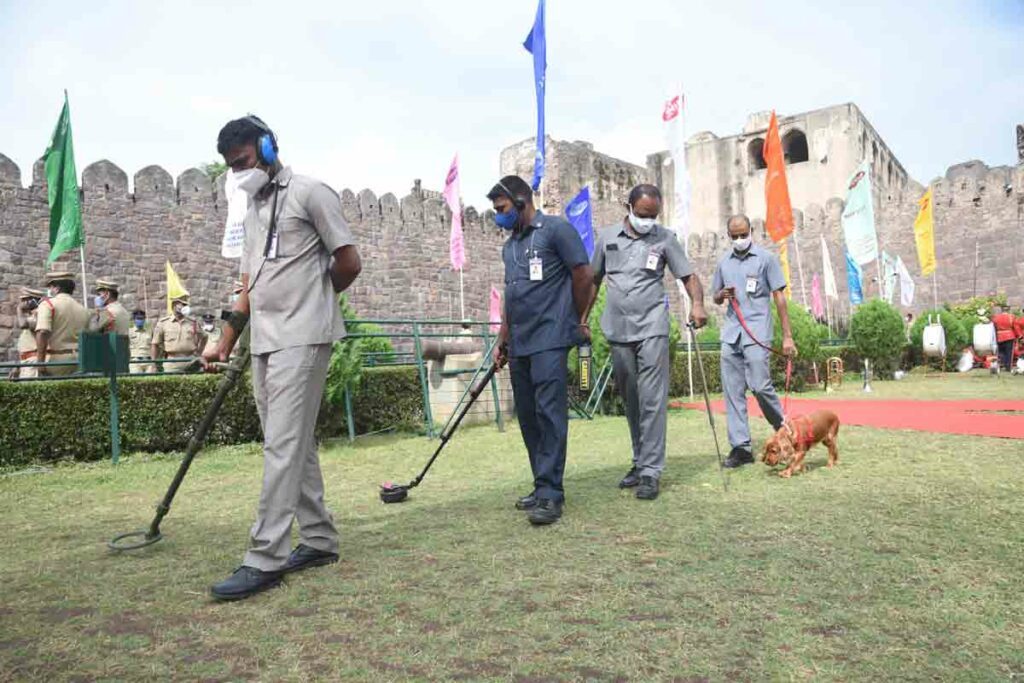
[243,344,338,571]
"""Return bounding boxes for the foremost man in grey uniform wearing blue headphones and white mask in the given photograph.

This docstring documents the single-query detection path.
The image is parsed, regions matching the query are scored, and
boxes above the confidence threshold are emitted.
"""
[204,116,361,600]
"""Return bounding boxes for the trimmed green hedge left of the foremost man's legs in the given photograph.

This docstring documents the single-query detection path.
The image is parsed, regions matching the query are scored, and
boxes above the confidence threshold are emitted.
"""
[0,375,260,466]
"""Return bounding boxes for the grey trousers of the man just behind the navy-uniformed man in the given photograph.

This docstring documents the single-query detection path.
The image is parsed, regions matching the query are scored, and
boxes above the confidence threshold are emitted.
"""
[609,337,672,478]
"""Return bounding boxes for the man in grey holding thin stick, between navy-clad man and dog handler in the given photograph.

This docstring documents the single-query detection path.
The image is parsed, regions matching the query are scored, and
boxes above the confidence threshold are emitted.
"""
[588,184,708,500]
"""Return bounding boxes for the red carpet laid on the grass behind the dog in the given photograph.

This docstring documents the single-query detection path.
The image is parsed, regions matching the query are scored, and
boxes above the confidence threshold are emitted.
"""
[683,398,1024,439]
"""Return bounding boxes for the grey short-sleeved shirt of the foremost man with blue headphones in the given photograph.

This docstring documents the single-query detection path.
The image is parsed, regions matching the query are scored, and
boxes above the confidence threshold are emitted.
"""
[241,168,354,353]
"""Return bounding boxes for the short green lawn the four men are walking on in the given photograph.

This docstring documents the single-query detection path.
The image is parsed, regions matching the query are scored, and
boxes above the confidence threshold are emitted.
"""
[0,378,1024,681]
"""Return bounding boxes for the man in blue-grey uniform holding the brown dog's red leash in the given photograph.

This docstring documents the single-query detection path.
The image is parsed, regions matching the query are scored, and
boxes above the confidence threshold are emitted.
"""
[712,215,797,467]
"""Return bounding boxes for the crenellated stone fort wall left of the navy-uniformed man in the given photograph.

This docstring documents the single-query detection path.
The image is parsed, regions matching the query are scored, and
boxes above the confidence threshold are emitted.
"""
[0,155,504,358]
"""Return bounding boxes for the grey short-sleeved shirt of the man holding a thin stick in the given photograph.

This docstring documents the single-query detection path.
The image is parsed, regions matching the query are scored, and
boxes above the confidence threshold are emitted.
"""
[591,221,693,344]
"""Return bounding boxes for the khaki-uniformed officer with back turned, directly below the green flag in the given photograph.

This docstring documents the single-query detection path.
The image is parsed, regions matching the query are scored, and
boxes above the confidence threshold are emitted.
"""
[36,272,89,376]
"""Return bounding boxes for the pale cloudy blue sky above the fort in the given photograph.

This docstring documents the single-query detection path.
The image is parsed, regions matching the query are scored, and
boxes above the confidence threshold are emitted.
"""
[0,0,1024,206]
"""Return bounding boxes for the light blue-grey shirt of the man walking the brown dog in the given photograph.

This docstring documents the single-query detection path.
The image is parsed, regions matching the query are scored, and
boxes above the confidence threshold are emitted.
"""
[711,245,785,346]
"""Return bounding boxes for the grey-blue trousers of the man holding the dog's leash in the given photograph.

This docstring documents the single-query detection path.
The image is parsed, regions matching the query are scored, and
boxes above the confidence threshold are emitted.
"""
[722,338,783,451]
